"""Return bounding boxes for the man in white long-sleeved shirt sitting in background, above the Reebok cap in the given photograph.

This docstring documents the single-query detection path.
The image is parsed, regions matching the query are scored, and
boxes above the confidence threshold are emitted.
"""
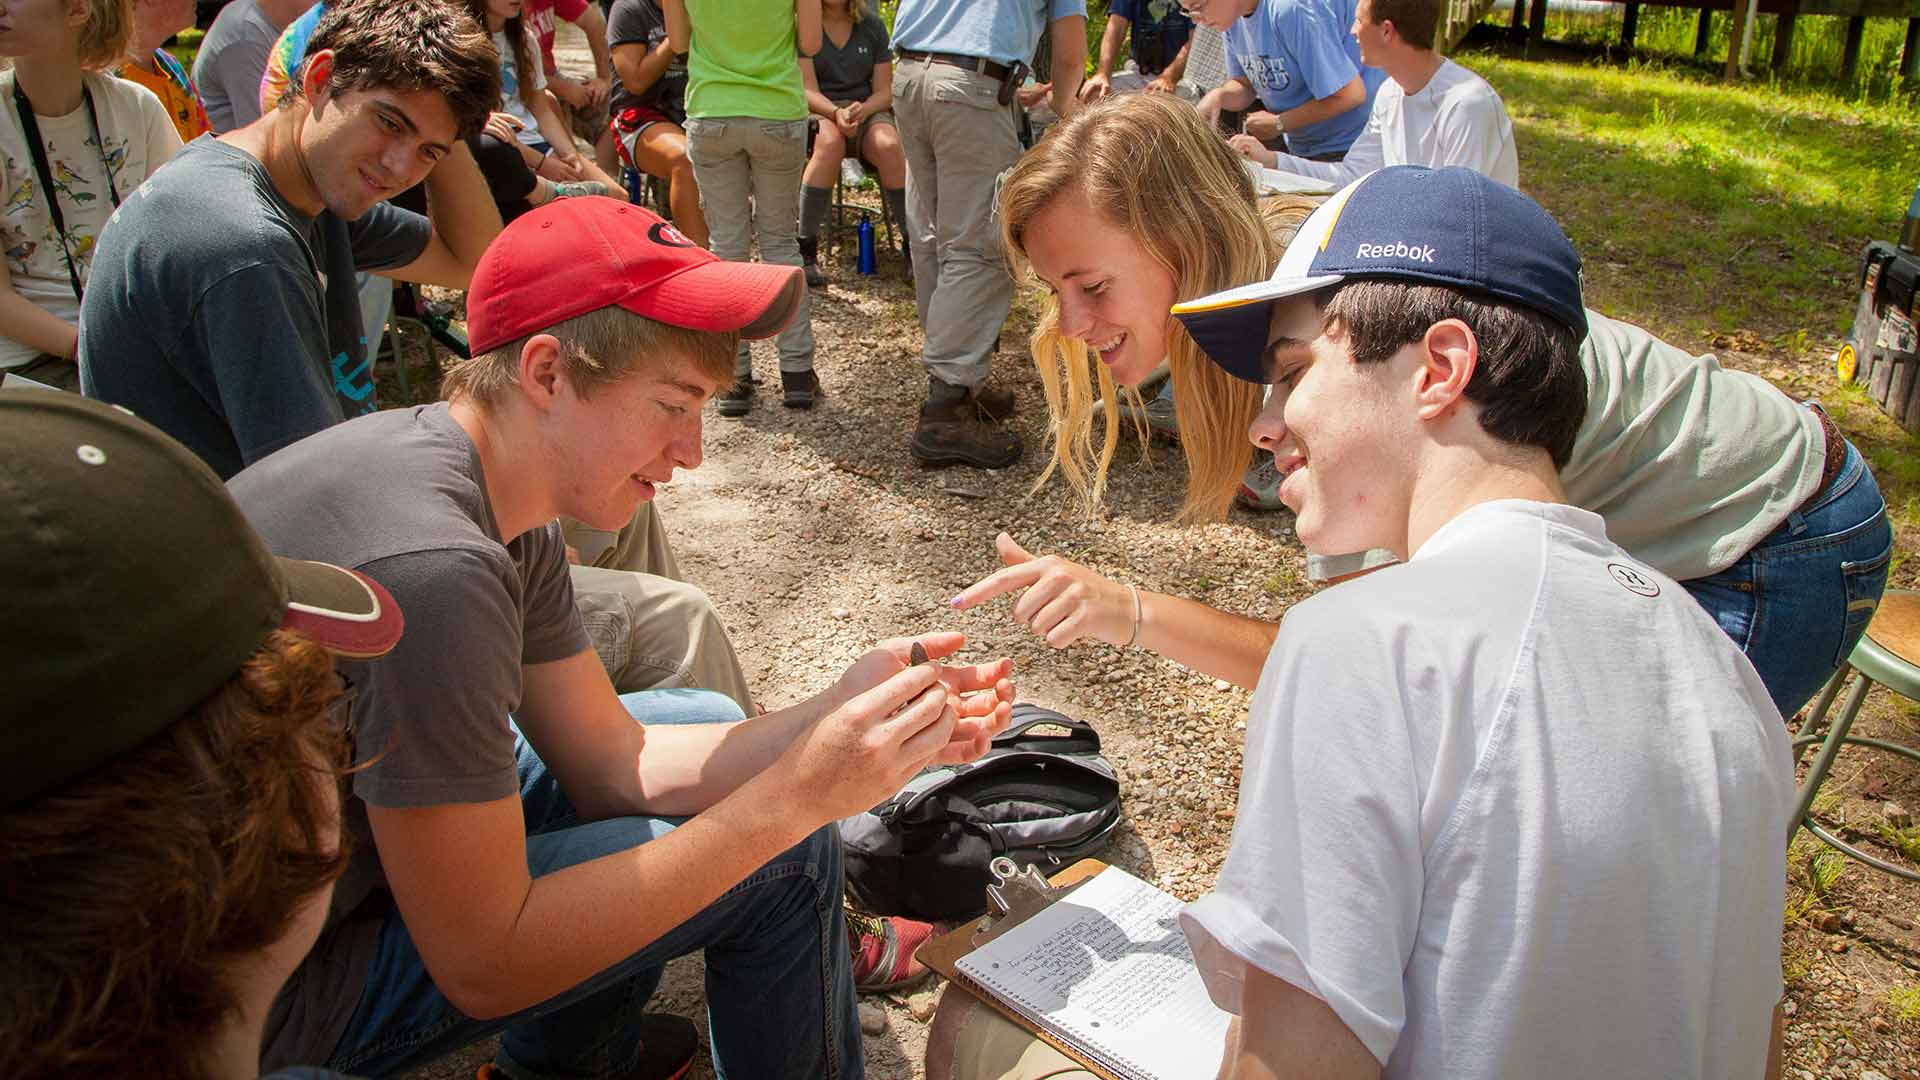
[1231,0,1521,186]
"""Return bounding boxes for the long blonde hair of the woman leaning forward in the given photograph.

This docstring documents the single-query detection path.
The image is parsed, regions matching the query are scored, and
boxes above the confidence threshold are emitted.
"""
[1000,94,1311,521]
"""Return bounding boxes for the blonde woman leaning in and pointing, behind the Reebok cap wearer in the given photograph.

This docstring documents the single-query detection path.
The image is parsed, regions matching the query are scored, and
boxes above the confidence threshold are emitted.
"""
[954,94,1893,717]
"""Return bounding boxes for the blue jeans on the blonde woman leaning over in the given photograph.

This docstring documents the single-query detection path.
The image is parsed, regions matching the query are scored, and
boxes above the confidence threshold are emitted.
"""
[1680,444,1893,717]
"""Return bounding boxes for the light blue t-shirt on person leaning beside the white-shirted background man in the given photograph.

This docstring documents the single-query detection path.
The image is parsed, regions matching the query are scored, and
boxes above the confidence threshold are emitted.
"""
[1227,0,1386,158]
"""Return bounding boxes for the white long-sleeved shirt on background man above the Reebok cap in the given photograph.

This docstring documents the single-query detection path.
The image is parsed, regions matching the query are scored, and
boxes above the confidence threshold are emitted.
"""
[1275,60,1521,188]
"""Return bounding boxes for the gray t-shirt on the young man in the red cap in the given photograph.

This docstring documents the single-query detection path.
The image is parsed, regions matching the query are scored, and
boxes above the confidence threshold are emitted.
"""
[228,404,589,1067]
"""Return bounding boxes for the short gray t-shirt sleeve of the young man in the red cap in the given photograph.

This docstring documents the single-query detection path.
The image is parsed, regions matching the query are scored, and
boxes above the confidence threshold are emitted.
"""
[344,550,520,807]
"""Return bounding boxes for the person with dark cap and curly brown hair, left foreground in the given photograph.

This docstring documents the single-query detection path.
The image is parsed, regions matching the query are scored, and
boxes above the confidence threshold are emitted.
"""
[0,390,401,1080]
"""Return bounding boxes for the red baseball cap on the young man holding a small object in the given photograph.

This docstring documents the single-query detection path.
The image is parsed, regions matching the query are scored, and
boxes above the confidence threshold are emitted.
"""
[467,196,806,356]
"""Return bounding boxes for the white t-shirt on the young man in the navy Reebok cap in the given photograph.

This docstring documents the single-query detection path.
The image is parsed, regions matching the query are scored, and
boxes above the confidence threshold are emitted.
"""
[1183,500,1793,1080]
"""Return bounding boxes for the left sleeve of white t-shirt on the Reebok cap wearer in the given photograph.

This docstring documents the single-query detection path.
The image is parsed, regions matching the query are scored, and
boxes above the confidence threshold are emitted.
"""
[1183,605,1423,1065]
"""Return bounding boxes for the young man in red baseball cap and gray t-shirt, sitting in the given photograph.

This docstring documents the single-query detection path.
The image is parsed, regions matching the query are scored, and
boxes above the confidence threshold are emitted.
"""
[232,198,1012,1078]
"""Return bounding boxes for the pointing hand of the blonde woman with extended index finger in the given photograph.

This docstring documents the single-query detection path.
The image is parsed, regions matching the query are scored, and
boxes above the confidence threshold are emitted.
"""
[952,532,1135,650]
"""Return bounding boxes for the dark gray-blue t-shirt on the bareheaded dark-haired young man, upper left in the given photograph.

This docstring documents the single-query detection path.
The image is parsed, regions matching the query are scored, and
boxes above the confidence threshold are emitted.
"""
[81,136,432,477]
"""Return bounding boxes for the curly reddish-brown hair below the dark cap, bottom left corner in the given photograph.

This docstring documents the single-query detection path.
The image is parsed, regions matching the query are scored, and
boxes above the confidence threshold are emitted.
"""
[0,630,348,1078]
